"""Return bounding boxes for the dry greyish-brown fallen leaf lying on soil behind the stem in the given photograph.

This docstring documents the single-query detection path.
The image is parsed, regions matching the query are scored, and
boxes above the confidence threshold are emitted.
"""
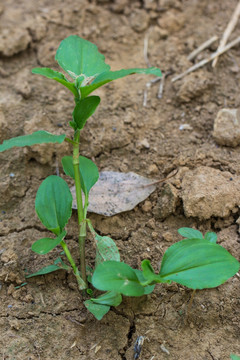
[71,171,156,216]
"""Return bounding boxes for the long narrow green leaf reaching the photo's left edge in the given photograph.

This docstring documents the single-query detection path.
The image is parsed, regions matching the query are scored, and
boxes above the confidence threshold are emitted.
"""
[0,130,66,152]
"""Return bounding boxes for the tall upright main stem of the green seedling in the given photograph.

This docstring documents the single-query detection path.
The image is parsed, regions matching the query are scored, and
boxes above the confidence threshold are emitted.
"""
[73,130,87,283]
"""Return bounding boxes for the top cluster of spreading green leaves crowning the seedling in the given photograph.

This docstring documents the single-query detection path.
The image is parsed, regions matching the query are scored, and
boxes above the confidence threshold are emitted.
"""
[32,35,162,99]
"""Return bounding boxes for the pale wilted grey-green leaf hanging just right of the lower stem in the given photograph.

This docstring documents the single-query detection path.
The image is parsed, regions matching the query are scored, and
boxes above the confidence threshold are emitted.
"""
[95,233,120,266]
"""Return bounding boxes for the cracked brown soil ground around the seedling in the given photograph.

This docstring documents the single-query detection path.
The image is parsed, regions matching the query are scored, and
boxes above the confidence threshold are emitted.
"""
[0,0,240,360]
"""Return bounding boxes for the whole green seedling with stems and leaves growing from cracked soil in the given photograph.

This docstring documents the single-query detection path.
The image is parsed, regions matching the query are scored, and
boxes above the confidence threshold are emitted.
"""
[0,36,239,320]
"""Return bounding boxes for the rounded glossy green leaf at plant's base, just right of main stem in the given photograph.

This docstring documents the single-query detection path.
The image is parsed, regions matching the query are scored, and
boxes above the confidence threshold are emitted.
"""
[92,261,144,296]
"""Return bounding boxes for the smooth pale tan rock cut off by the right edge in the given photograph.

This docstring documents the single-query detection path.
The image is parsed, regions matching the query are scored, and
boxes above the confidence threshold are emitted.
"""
[213,109,240,147]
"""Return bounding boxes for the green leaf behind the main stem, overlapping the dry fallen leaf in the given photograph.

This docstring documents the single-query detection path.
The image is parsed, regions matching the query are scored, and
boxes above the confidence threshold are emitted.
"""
[62,156,99,196]
